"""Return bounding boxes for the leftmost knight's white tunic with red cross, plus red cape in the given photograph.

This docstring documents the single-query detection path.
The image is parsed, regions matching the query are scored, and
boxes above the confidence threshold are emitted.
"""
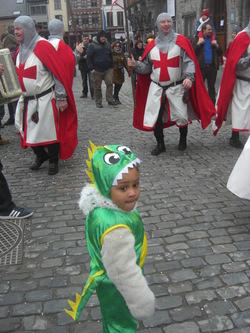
[15,38,78,159]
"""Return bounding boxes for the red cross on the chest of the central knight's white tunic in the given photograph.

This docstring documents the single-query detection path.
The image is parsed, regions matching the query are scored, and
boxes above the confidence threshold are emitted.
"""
[152,52,180,82]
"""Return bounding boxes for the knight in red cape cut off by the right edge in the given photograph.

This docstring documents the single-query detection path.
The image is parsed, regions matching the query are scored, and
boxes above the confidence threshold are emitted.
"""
[214,23,250,149]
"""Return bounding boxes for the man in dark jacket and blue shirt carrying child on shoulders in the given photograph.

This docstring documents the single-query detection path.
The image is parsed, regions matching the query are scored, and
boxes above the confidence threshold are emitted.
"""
[192,23,222,104]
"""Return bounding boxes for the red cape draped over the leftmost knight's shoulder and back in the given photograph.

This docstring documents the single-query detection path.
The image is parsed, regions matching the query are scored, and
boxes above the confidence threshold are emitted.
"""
[17,40,78,160]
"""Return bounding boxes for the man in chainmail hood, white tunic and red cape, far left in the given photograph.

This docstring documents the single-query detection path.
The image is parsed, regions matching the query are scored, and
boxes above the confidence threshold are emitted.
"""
[14,16,78,175]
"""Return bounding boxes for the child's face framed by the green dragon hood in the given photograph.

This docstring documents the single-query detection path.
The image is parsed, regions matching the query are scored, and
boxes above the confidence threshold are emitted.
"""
[110,168,140,212]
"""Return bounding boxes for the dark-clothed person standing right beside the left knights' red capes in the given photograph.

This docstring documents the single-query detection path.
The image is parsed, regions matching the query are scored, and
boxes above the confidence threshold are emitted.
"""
[76,34,94,99]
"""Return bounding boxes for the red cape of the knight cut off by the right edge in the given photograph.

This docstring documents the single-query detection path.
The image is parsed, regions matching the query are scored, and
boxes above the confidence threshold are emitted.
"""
[214,31,250,135]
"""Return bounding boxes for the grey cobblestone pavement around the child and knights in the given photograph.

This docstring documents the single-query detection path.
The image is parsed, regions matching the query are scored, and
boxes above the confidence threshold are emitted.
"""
[0,68,250,333]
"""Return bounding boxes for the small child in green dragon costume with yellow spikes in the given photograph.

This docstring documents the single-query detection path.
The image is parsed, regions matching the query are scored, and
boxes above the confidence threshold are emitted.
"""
[65,142,155,333]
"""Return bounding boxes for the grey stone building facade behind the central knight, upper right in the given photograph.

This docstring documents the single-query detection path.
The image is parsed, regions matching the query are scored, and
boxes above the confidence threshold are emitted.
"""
[127,0,250,50]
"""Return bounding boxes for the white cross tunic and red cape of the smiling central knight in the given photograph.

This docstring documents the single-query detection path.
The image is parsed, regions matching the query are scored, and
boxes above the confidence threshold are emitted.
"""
[133,35,215,131]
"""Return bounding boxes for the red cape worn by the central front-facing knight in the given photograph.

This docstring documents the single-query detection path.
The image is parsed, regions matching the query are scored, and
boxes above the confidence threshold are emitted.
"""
[133,35,216,131]
